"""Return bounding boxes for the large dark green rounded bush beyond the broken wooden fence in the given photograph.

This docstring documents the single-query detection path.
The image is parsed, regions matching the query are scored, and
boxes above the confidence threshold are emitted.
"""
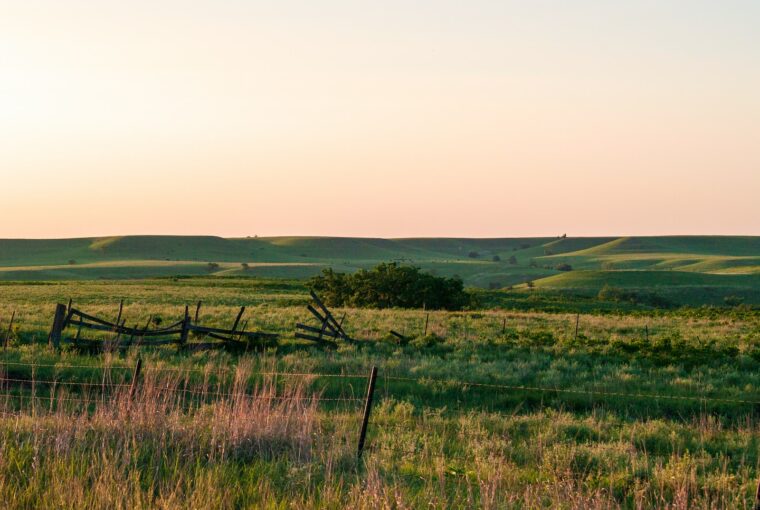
[309,262,471,310]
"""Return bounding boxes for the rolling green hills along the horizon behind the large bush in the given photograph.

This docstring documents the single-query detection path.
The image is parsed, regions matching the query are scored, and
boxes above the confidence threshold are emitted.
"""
[0,236,760,303]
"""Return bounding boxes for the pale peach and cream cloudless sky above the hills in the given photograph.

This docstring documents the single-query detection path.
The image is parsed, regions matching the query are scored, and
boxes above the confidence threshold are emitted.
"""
[0,0,760,238]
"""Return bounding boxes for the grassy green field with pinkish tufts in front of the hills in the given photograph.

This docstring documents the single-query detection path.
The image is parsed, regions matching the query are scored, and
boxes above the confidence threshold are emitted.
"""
[0,276,760,508]
